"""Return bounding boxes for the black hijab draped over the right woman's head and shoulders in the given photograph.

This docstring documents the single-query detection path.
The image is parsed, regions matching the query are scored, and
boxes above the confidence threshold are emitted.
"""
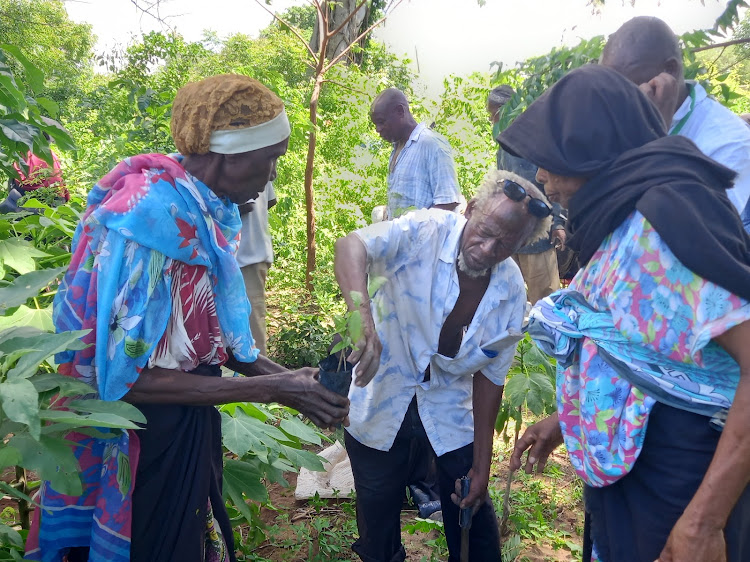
[498,65,750,300]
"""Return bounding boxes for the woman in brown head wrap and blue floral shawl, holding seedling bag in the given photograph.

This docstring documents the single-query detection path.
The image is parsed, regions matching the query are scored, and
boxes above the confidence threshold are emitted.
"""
[27,75,348,562]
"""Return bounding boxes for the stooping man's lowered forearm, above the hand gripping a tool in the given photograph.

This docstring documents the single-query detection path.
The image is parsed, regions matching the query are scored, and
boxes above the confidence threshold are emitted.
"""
[472,371,503,474]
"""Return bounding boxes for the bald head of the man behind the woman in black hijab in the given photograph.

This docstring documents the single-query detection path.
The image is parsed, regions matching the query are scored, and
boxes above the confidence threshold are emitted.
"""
[599,16,685,85]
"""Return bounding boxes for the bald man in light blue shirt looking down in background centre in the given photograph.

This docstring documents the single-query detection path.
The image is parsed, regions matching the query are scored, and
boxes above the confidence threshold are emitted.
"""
[370,88,461,219]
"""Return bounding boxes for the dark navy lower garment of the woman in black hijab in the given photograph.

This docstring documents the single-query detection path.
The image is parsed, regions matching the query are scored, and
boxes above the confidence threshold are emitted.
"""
[584,403,750,562]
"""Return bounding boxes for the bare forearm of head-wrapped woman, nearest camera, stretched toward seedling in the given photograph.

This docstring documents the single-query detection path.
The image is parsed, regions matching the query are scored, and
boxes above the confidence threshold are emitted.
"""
[123,367,285,406]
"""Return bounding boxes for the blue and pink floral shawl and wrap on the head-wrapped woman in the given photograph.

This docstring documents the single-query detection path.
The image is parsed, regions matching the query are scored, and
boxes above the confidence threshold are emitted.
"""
[27,154,258,562]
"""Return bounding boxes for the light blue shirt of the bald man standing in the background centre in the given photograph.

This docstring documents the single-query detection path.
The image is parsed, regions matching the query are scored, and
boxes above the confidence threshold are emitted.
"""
[388,123,461,219]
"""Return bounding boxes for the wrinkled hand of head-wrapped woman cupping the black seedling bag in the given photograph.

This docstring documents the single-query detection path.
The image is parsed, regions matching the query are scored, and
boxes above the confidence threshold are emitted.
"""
[283,367,349,429]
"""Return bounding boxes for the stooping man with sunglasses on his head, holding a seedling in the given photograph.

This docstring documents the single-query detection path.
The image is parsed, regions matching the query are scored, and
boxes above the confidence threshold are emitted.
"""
[335,171,551,562]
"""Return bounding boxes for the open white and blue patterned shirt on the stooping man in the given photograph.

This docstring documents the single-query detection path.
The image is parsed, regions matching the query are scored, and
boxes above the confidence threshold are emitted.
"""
[347,209,526,456]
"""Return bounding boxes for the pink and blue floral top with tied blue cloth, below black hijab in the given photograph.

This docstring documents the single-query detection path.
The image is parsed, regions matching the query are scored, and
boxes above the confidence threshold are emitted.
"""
[534,208,750,487]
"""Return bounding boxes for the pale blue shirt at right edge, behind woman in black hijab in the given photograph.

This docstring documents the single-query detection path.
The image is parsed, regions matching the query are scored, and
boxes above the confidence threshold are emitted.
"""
[669,82,750,222]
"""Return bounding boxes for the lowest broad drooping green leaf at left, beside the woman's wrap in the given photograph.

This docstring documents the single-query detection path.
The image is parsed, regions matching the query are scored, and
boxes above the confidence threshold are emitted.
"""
[9,434,83,496]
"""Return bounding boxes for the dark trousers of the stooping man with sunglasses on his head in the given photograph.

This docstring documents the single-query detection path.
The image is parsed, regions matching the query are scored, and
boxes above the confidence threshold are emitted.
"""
[345,398,501,562]
